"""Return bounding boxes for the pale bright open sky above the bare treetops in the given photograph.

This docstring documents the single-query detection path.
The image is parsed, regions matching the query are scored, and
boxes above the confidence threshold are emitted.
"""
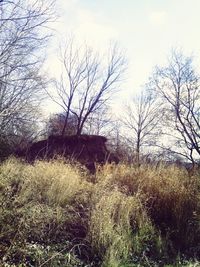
[45,0,200,114]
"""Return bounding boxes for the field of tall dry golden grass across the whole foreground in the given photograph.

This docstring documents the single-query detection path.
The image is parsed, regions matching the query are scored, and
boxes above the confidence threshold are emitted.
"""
[0,159,200,267]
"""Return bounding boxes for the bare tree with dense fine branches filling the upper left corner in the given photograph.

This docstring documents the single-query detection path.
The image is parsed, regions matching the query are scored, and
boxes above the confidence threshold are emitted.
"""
[0,0,52,141]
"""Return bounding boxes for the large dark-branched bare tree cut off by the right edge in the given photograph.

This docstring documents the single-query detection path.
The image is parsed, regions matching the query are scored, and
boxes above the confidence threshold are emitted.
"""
[152,51,200,163]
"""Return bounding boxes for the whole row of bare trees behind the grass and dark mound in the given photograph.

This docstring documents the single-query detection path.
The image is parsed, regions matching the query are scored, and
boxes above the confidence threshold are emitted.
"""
[0,0,200,164]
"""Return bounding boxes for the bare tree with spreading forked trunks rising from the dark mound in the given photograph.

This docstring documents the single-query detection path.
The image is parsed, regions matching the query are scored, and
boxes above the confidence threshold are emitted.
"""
[53,40,126,135]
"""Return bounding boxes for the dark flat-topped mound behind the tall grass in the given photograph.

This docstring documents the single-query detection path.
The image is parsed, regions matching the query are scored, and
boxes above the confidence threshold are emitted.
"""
[16,135,119,172]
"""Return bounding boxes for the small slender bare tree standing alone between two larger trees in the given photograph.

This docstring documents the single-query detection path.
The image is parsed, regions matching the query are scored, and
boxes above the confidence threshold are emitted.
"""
[122,90,162,165]
